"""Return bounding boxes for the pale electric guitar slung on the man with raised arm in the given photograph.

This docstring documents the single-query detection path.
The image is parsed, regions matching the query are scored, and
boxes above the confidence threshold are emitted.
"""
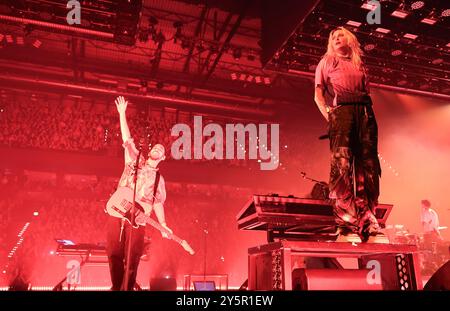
[106,187,195,255]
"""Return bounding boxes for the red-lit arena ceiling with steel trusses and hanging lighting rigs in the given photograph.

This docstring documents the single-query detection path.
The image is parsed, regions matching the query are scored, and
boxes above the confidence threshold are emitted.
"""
[0,0,450,118]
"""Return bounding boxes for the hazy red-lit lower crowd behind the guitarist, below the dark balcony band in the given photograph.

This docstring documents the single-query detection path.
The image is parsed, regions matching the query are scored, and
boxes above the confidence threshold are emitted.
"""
[0,173,252,284]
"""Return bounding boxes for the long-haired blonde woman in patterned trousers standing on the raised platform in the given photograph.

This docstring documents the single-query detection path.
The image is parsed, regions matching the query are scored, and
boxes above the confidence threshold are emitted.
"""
[314,27,388,243]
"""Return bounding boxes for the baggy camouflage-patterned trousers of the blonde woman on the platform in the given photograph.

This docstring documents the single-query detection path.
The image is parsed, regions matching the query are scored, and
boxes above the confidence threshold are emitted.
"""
[329,104,381,238]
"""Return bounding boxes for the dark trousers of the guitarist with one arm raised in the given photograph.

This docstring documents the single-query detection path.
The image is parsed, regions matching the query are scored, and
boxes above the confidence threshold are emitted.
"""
[106,217,145,290]
